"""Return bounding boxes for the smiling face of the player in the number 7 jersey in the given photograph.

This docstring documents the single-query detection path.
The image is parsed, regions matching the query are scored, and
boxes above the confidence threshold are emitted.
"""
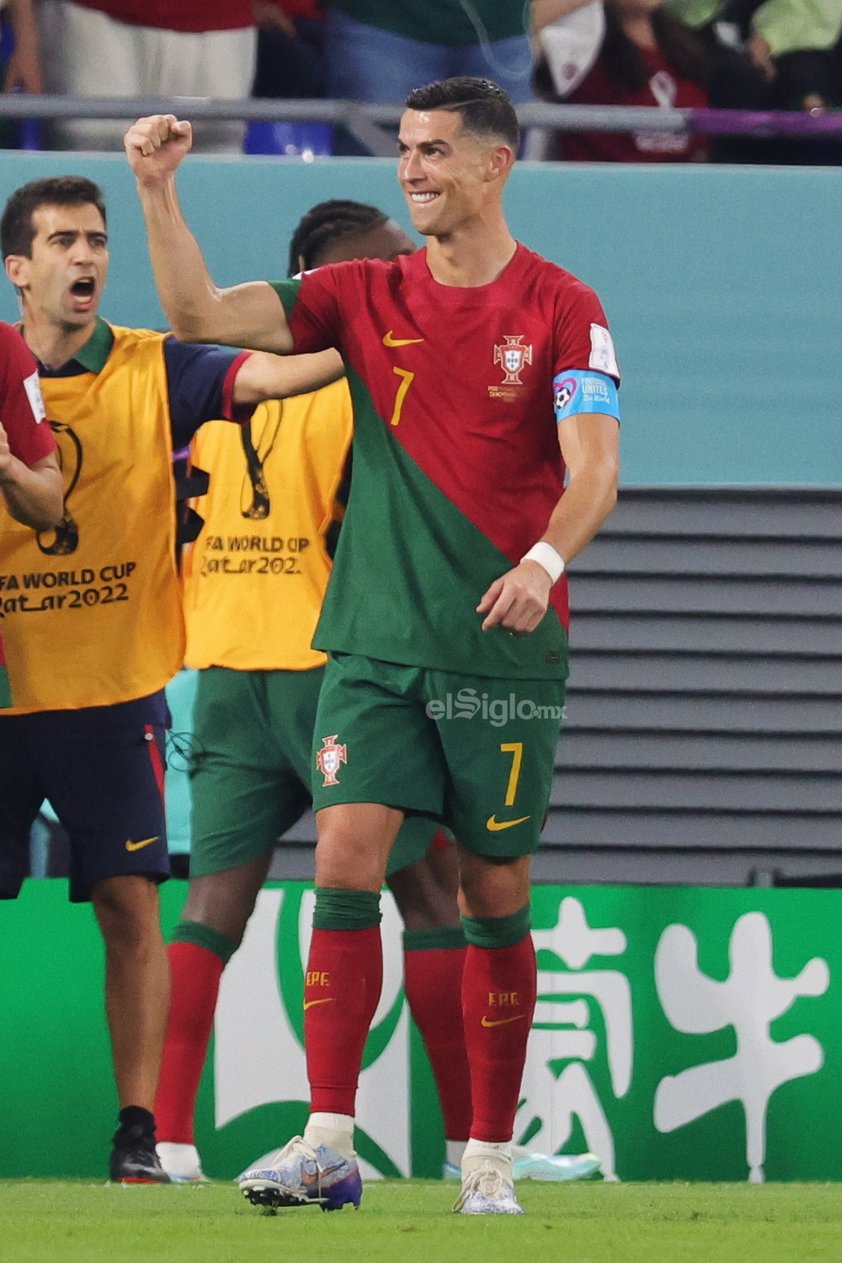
[398,110,514,239]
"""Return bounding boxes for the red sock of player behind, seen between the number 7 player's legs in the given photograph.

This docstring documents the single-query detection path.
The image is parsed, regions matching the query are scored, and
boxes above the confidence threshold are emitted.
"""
[404,947,471,1140]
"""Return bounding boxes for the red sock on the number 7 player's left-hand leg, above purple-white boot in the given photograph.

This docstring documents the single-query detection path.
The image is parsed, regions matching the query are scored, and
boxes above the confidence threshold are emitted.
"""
[304,925,382,1116]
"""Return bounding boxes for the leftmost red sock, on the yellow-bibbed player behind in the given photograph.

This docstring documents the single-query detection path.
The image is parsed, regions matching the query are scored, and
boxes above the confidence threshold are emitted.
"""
[155,942,225,1144]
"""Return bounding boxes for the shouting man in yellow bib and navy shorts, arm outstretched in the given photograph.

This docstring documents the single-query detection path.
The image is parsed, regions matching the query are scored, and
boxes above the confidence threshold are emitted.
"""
[0,176,341,1182]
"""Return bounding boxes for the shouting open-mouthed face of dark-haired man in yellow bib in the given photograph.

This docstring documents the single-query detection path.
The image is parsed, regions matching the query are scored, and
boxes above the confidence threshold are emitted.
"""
[6,202,109,333]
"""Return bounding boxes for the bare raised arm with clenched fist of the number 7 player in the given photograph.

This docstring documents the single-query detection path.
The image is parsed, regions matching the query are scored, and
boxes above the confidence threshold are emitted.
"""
[124,114,293,355]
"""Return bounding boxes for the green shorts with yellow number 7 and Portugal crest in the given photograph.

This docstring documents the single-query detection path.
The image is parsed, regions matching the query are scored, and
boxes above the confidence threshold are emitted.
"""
[313,653,564,856]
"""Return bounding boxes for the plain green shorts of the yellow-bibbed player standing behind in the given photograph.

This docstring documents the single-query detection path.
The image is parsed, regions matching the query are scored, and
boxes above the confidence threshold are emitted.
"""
[188,667,437,877]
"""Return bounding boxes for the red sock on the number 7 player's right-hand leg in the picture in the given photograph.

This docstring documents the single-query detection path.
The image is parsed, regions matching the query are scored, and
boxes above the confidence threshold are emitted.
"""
[462,935,537,1143]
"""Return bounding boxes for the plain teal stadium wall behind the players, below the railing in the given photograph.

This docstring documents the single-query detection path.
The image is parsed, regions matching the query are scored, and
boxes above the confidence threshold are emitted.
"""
[0,153,842,486]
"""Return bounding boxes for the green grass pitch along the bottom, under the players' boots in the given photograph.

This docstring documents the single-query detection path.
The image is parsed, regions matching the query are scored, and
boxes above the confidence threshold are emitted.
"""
[0,1180,842,1263]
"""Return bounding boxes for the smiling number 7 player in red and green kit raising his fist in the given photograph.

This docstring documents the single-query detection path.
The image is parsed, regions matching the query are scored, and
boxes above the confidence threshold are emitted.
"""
[125,78,619,1214]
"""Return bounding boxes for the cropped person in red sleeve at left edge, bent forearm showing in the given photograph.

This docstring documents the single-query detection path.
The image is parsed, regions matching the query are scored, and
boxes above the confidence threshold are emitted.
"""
[0,323,64,532]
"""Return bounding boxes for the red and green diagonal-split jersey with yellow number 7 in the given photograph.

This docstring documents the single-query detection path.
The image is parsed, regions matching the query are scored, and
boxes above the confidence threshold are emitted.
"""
[275,245,614,679]
